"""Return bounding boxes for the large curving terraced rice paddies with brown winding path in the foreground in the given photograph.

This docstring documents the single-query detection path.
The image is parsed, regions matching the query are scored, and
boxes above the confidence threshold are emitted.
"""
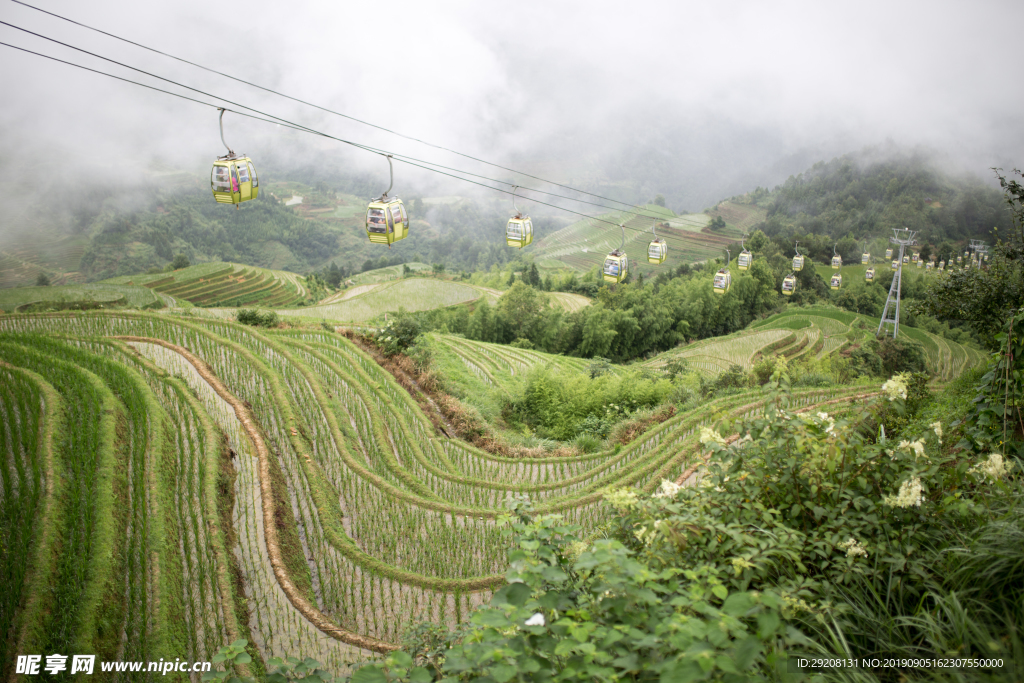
[0,311,897,677]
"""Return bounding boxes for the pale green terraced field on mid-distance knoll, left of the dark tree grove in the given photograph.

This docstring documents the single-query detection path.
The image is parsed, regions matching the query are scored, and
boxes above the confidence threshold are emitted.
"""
[278,278,491,323]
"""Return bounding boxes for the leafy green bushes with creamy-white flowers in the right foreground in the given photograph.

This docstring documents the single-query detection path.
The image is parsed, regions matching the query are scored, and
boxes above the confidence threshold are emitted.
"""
[352,372,1024,683]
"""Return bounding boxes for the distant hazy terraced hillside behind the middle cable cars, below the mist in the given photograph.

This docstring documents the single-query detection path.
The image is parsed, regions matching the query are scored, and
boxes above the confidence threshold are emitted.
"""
[534,204,735,271]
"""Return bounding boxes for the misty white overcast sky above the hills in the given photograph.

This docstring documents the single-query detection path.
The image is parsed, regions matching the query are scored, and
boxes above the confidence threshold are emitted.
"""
[0,0,1024,208]
